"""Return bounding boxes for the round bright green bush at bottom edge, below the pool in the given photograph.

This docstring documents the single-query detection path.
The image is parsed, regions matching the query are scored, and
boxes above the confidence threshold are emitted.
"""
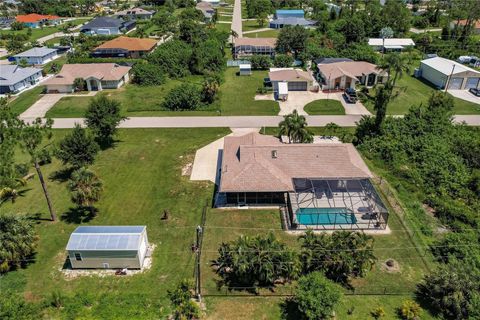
[293,272,342,320]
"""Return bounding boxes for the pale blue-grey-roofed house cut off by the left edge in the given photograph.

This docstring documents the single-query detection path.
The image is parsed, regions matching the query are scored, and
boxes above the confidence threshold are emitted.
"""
[0,64,42,94]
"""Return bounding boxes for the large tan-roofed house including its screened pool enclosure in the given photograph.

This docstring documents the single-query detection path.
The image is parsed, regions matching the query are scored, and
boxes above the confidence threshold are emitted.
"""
[215,133,388,229]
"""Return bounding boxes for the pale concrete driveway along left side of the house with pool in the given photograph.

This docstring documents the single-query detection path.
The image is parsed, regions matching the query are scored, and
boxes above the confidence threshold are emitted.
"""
[190,128,260,184]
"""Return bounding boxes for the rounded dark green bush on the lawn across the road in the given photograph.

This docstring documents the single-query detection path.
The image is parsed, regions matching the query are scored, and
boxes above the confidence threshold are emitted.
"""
[162,83,202,111]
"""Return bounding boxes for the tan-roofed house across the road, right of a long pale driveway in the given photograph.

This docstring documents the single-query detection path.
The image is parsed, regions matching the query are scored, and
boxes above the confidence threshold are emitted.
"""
[45,63,131,93]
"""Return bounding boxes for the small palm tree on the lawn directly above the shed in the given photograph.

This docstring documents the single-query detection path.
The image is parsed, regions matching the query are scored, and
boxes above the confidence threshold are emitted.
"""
[68,168,103,213]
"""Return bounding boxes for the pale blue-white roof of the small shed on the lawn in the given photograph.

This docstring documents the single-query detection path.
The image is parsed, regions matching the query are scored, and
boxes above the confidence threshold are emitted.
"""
[67,226,146,251]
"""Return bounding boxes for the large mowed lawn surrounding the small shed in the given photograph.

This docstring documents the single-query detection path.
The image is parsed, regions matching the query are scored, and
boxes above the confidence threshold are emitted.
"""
[0,128,229,319]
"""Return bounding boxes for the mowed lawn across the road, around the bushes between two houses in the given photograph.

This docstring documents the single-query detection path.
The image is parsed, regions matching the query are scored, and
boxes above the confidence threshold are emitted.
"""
[47,68,279,118]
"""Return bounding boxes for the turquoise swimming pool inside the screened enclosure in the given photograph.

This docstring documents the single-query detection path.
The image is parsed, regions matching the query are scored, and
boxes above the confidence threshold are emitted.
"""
[297,208,357,225]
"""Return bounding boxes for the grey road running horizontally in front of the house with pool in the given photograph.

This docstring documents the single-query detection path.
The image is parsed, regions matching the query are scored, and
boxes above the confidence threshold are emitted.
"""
[47,114,480,129]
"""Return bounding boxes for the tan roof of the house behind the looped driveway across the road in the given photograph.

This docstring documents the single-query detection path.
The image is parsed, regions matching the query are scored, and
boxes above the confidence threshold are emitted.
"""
[318,61,386,79]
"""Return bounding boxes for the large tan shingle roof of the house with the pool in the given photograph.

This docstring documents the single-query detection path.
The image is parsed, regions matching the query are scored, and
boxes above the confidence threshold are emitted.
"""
[220,133,372,192]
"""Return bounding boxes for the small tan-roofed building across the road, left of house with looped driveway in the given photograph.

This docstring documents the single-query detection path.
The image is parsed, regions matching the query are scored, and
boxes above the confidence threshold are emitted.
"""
[268,68,314,99]
